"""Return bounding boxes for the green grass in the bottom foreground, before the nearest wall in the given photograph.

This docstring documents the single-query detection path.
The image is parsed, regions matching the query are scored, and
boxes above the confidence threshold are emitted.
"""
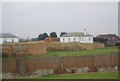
[31,72,118,79]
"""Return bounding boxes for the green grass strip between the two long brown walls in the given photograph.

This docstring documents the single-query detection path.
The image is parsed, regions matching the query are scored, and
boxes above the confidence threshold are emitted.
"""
[28,47,118,57]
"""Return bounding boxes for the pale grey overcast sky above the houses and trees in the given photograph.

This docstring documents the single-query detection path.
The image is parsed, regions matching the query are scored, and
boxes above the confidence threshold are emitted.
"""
[2,2,118,38]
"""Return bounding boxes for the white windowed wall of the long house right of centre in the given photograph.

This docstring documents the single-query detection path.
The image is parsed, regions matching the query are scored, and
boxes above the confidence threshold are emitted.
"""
[60,36,93,43]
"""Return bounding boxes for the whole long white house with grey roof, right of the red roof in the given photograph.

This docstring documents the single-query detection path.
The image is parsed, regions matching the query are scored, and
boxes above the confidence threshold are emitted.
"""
[60,32,93,43]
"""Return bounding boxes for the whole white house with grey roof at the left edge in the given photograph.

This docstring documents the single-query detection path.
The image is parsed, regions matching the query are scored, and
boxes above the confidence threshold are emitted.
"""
[0,33,19,44]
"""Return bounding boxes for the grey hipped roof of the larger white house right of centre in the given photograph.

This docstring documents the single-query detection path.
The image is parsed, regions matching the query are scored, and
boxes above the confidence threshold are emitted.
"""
[61,32,92,37]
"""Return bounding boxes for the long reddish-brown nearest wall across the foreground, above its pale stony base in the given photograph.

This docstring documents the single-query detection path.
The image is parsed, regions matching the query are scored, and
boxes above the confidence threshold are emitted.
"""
[2,54,118,75]
